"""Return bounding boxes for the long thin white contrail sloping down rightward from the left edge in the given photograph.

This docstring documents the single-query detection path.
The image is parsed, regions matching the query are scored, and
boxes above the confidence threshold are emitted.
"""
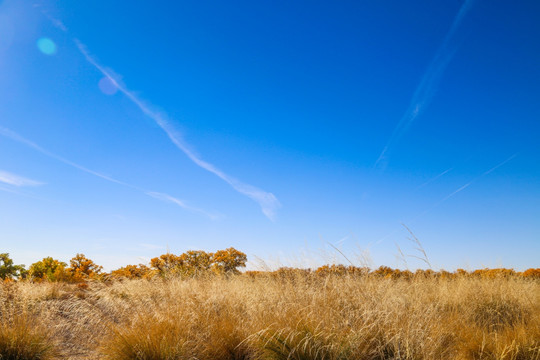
[0,126,218,219]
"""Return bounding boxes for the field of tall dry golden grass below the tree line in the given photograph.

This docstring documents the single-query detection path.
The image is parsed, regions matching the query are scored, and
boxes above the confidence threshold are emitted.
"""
[0,272,540,360]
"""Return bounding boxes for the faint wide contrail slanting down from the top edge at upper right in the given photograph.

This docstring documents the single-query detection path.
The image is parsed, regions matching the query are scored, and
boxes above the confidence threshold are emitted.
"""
[374,0,474,169]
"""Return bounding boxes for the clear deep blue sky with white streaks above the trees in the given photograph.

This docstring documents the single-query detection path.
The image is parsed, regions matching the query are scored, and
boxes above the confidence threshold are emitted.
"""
[0,0,540,270]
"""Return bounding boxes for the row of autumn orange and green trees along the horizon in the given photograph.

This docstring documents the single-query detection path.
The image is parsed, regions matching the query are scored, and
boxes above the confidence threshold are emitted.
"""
[0,247,540,283]
